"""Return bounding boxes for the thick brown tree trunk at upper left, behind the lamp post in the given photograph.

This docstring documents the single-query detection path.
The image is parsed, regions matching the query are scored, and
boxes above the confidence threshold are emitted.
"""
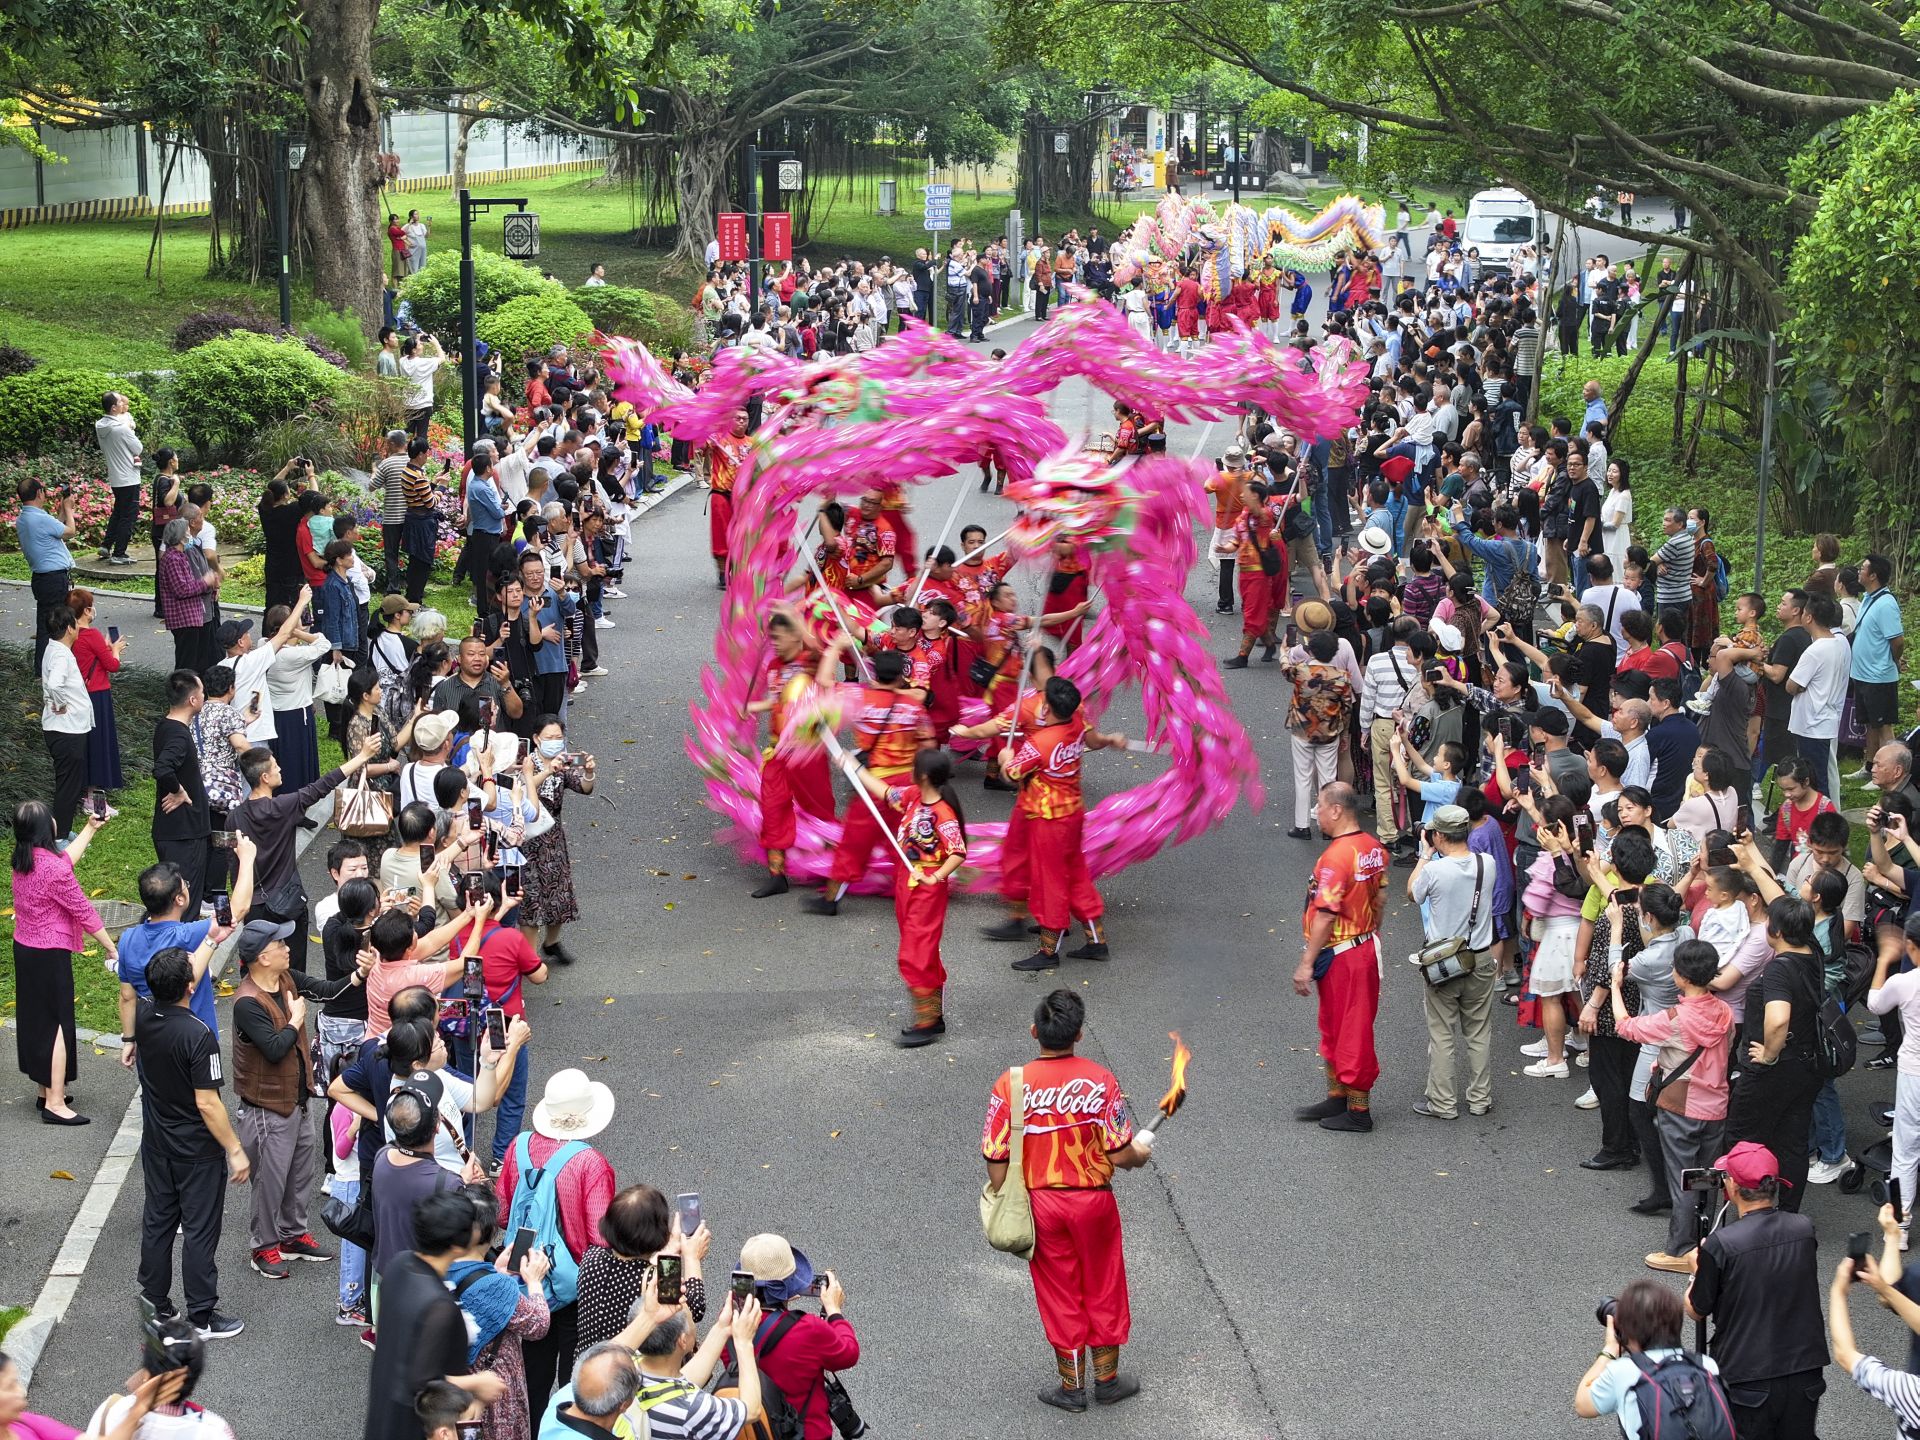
[301,0,386,336]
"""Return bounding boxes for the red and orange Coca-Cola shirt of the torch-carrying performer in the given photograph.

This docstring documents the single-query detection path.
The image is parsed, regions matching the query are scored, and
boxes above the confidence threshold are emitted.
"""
[979,1056,1133,1190]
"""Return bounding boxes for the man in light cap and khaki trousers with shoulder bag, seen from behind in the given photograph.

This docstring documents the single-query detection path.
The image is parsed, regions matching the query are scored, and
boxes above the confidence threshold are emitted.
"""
[1407,804,1498,1119]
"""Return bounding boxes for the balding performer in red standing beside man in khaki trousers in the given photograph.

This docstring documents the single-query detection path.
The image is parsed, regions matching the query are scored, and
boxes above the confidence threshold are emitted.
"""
[1294,780,1388,1133]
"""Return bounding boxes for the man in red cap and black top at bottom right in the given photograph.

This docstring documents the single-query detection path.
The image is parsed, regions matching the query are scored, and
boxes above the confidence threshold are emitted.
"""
[1686,1144,1826,1440]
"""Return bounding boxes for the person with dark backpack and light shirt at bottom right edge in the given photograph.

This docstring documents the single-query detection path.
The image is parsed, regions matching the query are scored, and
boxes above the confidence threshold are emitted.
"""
[1572,1281,1734,1440]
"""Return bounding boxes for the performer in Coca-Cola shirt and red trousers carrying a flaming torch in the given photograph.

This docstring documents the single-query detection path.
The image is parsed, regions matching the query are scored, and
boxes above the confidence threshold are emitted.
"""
[979,991,1154,1411]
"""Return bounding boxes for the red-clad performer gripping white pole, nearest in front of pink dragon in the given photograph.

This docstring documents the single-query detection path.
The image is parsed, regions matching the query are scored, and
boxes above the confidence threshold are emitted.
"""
[841,751,966,1050]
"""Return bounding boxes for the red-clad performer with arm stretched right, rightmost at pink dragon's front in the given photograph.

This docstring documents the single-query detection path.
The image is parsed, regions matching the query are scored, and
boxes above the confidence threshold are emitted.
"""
[1000,676,1127,970]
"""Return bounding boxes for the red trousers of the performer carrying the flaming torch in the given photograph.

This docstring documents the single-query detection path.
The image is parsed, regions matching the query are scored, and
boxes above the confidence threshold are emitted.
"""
[1027,1190,1133,1354]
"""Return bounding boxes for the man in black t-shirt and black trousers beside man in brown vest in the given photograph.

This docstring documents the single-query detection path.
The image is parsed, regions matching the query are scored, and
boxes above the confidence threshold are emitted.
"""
[134,948,250,1340]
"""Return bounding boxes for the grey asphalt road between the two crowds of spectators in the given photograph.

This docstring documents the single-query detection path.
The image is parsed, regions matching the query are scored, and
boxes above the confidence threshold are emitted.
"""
[0,305,1905,1440]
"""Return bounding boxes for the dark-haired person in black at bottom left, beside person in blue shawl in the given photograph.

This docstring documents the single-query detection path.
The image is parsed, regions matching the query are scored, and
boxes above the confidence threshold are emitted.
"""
[365,1190,507,1440]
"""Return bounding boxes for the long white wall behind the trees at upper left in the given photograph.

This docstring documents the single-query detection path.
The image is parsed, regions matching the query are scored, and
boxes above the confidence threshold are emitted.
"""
[0,111,607,228]
